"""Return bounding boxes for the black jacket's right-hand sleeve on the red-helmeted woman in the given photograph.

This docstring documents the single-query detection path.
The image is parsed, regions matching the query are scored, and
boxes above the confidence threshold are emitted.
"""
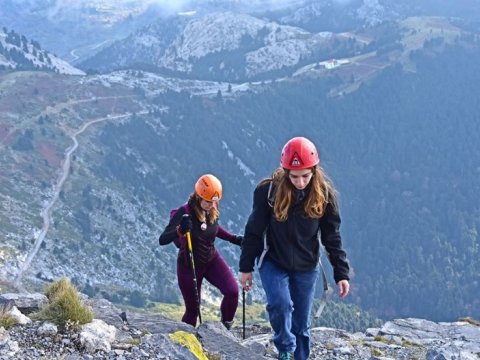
[320,204,350,283]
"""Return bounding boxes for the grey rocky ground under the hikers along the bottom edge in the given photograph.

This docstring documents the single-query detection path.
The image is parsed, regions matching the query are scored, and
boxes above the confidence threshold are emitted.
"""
[0,294,480,360]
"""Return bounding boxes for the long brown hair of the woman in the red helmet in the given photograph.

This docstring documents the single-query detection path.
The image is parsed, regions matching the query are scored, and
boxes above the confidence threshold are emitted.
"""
[258,165,337,221]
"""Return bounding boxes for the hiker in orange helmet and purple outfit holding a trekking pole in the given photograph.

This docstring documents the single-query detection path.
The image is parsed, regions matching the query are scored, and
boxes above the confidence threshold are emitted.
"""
[159,174,242,329]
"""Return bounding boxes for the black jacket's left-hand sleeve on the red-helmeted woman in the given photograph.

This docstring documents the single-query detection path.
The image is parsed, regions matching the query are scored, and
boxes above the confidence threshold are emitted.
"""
[239,183,272,273]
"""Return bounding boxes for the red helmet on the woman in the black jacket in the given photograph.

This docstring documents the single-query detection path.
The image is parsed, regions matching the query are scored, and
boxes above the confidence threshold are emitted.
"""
[280,137,320,170]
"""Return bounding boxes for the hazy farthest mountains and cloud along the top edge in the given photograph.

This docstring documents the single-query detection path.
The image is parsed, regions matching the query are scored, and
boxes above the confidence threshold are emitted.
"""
[0,0,480,64]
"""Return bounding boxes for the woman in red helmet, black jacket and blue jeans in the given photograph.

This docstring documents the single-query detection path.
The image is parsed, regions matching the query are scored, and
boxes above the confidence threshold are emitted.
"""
[240,137,349,360]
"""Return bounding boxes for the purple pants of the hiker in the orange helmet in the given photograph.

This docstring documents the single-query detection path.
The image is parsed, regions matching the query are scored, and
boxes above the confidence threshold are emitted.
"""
[177,252,238,326]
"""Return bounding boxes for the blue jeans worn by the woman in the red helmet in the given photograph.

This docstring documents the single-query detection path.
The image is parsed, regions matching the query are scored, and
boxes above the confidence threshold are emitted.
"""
[259,259,319,360]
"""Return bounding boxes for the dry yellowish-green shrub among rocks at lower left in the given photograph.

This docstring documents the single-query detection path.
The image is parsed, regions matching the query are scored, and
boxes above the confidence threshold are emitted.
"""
[32,278,93,328]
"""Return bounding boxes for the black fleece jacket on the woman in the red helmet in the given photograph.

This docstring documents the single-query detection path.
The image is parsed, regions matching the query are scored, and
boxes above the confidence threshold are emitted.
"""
[240,183,349,283]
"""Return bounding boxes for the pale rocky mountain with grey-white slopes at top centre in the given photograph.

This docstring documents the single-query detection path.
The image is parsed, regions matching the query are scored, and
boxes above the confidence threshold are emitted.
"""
[79,12,363,81]
